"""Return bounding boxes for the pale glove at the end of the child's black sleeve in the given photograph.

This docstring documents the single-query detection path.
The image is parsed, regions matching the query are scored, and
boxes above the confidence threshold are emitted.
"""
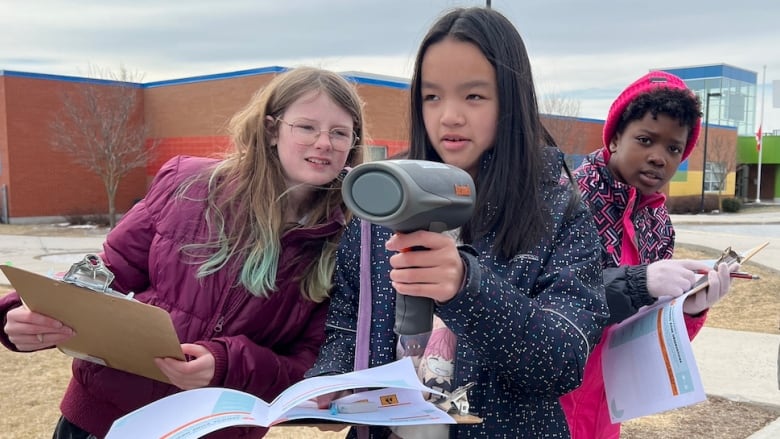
[647,259,710,299]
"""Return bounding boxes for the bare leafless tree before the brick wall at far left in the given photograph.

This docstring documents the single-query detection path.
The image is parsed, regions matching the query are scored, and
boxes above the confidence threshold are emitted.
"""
[50,66,156,228]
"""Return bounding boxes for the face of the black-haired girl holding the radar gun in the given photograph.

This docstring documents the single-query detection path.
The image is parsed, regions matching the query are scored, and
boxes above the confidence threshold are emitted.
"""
[420,38,498,178]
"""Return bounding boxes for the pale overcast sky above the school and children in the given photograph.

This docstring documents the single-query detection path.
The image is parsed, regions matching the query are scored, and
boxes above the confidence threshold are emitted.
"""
[0,0,780,133]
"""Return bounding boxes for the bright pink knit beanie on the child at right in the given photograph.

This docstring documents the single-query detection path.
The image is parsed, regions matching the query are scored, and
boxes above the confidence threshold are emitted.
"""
[602,71,701,161]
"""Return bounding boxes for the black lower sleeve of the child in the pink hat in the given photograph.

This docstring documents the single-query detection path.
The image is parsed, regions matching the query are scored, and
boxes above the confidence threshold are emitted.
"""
[604,265,656,325]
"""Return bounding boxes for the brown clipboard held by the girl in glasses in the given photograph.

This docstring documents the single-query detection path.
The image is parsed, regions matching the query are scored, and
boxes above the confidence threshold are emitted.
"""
[0,262,185,383]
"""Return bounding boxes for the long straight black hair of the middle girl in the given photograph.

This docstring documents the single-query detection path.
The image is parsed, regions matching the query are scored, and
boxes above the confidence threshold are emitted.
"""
[409,8,554,258]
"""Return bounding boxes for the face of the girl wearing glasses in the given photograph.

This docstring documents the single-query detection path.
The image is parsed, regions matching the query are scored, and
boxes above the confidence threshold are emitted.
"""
[269,91,354,188]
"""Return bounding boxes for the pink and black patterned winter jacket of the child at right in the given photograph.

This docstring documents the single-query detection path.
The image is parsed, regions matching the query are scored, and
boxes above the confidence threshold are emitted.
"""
[560,148,707,439]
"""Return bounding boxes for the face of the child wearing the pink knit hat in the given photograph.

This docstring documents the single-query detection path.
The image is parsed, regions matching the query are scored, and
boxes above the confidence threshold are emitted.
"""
[607,112,688,195]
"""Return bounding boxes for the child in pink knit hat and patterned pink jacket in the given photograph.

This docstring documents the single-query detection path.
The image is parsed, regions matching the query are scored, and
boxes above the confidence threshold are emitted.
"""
[561,71,738,439]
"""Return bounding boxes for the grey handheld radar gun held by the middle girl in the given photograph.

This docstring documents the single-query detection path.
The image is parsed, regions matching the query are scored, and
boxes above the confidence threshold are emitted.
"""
[341,160,476,335]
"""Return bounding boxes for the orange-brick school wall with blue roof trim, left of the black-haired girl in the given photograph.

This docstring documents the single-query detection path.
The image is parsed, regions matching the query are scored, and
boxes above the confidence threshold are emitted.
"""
[0,66,408,223]
